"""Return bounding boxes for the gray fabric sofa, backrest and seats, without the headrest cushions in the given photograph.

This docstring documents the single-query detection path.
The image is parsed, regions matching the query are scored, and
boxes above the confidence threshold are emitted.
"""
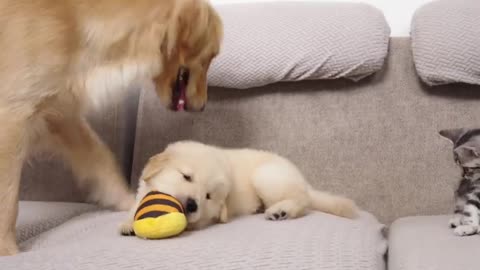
[0,1,480,270]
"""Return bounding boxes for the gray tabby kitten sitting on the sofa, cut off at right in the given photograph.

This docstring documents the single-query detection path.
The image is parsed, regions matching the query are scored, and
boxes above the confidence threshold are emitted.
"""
[440,129,480,236]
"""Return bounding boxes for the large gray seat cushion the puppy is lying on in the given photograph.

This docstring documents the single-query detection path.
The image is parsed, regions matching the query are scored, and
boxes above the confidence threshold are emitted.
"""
[6,212,386,270]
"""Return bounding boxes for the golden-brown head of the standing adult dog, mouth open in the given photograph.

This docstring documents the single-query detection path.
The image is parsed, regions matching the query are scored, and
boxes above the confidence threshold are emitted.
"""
[155,0,223,111]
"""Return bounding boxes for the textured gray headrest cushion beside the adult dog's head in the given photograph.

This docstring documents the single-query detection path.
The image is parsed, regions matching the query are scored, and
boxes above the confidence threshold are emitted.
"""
[209,2,390,89]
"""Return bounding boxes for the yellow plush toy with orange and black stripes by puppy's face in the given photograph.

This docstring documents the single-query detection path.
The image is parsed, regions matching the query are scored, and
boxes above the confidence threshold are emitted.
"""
[133,191,187,239]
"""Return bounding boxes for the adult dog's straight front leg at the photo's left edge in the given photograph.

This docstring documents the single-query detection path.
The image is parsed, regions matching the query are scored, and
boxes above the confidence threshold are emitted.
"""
[0,112,28,256]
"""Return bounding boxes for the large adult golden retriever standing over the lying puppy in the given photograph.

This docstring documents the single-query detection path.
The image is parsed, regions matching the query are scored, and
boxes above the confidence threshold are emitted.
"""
[0,0,222,255]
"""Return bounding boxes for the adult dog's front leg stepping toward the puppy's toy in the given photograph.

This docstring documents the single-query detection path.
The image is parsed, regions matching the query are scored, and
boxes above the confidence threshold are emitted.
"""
[47,118,134,210]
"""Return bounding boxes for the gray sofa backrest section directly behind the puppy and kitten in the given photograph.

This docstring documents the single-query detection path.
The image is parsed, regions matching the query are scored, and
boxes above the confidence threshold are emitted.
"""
[132,38,480,223]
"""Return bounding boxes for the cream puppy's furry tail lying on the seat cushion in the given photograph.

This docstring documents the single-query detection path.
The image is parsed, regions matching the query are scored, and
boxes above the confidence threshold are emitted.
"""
[308,188,358,219]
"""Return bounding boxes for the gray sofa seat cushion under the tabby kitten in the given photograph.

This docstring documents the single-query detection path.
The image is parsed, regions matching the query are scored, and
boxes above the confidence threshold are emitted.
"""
[388,216,480,270]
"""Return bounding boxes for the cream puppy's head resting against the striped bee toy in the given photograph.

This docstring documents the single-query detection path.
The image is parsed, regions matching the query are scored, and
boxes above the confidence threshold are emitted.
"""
[141,142,231,229]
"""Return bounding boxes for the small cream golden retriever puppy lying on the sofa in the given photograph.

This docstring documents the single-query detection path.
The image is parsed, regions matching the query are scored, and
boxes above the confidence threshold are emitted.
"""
[120,141,357,235]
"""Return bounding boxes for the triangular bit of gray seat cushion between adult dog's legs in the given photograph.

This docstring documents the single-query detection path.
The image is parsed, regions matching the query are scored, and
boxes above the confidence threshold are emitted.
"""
[17,201,96,243]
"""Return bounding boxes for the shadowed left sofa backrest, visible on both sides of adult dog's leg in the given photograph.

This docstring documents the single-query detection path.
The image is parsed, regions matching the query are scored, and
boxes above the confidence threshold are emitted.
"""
[20,89,139,202]
